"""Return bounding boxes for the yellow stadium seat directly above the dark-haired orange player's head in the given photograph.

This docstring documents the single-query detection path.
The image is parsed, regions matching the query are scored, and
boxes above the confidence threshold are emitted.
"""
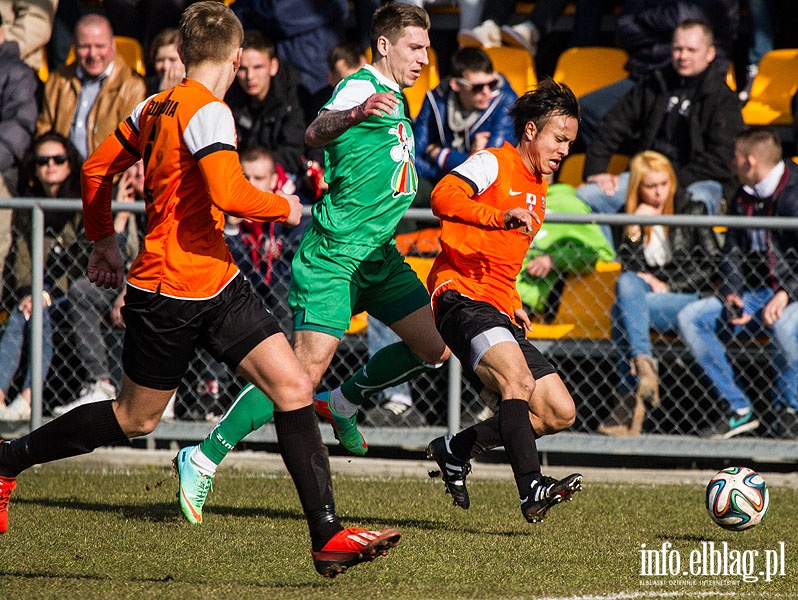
[553,46,629,98]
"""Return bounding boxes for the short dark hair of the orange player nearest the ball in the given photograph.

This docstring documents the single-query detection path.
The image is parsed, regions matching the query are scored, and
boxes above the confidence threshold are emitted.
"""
[508,77,582,141]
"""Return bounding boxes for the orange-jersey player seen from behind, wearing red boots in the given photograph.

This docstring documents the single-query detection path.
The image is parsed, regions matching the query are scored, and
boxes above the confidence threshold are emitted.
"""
[0,2,400,577]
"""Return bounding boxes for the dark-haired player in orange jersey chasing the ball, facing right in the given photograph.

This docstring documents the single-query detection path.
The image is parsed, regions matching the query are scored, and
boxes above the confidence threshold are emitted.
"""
[427,79,582,523]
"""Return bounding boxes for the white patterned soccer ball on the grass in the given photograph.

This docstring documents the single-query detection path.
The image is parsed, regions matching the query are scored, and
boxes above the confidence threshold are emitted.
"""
[707,467,770,531]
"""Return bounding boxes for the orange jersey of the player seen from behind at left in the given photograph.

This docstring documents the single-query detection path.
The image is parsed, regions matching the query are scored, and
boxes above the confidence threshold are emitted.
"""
[81,79,289,299]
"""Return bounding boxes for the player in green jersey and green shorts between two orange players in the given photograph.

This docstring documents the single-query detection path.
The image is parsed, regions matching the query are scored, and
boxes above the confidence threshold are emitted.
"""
[176,2,449,522]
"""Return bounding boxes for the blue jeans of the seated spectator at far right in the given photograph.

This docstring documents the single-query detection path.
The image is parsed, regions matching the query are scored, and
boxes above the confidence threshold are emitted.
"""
[679,288,798,412]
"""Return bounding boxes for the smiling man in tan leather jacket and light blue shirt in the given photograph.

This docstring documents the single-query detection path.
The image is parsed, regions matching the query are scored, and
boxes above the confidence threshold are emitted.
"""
[36,14,146,158]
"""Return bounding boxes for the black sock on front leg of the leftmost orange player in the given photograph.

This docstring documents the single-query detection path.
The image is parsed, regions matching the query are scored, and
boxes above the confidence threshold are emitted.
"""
[274,406,343,552]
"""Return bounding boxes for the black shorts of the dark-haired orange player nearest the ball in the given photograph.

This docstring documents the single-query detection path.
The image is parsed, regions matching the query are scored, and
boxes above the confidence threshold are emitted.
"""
[435,290,557,391]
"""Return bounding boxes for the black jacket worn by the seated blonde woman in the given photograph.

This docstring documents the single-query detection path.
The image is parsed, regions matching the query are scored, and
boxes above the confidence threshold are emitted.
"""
[618,195,720,292]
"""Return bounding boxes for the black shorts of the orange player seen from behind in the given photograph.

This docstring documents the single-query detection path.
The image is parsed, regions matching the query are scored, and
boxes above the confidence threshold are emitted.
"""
[122,274,281,390]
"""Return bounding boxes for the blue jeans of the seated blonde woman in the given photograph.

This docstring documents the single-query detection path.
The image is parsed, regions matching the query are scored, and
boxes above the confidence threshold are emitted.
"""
[610,271,699,394]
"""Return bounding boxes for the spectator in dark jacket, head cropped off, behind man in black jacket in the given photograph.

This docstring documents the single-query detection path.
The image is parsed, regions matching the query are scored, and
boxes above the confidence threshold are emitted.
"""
[578,0,740,148]
